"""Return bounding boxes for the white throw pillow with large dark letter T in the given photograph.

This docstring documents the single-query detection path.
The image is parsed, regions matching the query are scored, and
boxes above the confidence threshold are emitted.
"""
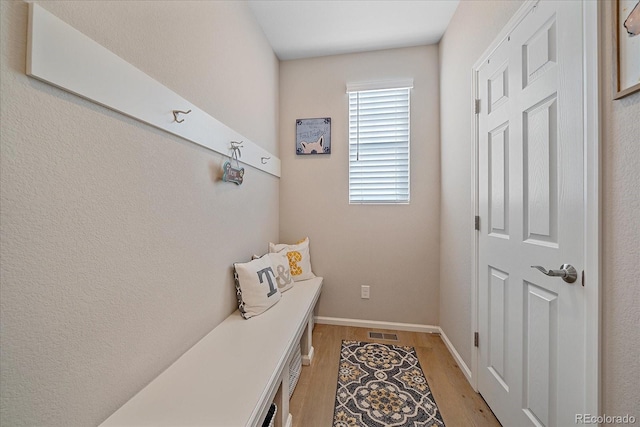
[233,255,282,319]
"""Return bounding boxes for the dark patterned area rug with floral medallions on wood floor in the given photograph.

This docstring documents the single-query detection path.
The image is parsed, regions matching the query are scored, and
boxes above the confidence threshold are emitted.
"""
[333,341,444,427]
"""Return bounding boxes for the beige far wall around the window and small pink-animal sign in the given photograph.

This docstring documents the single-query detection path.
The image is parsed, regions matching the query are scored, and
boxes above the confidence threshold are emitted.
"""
[280,46,440,325]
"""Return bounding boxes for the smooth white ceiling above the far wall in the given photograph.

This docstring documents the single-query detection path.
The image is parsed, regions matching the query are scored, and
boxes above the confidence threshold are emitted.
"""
[249,0,459,60]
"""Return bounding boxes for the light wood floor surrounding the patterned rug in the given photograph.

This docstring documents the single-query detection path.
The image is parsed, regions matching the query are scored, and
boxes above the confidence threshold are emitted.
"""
[289,325,500,427]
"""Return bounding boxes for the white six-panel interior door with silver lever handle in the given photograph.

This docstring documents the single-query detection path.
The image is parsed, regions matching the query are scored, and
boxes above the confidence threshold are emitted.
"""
[477,0,586,426]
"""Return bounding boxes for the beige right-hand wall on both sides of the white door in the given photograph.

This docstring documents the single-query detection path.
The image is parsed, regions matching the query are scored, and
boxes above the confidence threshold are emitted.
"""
[440,1,640,418]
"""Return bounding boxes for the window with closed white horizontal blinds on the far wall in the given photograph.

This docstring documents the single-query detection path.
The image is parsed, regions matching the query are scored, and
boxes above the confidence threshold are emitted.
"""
[347,82,413,204]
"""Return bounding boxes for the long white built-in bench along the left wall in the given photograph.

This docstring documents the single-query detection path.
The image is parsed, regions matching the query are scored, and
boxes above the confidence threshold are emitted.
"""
[102,277,322,427]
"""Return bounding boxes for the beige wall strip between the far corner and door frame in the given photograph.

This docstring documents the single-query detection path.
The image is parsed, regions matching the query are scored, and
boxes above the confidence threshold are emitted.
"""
[440,1,521,368]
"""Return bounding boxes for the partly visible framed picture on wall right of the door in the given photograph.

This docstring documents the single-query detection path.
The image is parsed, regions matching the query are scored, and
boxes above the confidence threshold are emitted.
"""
[611,0,640,99]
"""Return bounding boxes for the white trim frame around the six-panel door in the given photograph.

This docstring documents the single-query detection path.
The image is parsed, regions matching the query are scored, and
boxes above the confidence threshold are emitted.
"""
[469,0,602,414]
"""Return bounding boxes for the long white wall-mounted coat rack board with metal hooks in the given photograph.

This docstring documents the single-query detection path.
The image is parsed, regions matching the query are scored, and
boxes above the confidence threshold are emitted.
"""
[27,3,280,177]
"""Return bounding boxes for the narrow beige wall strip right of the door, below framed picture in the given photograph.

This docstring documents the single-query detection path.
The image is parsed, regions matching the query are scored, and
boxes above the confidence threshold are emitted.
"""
[600,3,640,419]
